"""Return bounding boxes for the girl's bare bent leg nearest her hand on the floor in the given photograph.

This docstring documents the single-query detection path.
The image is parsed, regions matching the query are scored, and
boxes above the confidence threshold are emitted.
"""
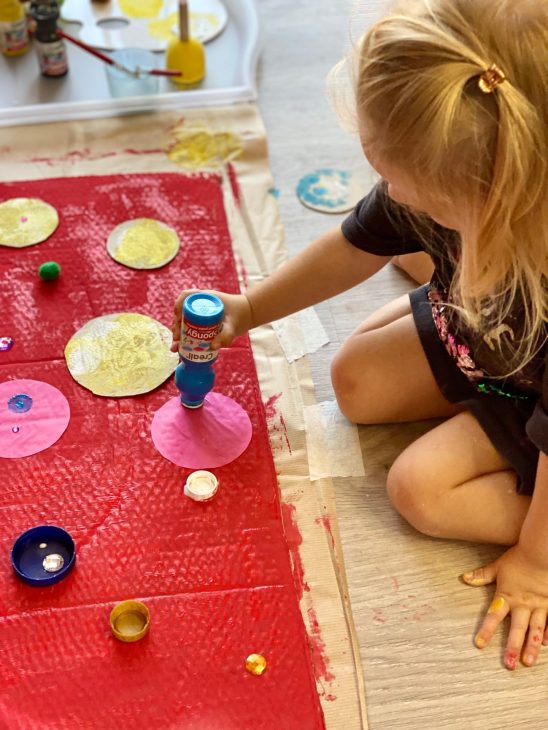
[387,411,531,545]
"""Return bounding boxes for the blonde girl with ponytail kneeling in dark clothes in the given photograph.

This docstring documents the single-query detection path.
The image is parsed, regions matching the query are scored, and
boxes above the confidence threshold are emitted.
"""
[173,0,548,669]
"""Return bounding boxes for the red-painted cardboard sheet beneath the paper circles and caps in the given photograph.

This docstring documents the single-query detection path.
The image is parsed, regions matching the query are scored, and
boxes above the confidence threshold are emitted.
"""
[0,173,324,730]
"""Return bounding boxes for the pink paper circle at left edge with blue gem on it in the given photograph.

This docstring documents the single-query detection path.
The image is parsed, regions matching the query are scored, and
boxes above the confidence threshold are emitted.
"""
[0,380,70,459]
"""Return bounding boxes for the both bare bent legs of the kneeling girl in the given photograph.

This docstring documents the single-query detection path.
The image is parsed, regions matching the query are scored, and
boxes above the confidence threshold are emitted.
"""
[332,296,530,545]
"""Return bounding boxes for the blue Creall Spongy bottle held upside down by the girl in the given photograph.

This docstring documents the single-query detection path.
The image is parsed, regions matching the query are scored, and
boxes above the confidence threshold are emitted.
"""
[175,292,224,408]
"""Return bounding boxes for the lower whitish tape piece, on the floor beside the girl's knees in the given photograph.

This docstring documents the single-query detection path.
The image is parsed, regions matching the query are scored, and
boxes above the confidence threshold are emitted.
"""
[303,401,365,481]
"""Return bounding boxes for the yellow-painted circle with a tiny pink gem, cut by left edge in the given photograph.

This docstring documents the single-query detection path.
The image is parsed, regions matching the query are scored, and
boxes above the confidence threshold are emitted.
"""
[0,198,59,248]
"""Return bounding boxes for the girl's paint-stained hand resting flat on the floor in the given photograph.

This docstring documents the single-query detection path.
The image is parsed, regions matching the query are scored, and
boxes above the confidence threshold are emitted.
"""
[462,543,548,669]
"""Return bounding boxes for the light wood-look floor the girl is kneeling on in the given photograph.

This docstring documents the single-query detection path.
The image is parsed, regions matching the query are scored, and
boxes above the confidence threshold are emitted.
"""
[258,0,548,730]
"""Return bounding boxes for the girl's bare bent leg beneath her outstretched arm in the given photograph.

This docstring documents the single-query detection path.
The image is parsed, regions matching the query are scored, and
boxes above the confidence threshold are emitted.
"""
[331,295,460,423]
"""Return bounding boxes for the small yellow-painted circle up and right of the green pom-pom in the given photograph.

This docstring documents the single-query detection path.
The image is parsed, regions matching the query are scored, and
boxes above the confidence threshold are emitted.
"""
[107,218,180,269]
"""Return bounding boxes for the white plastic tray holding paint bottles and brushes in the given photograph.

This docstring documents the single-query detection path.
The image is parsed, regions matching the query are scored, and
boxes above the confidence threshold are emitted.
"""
[0,0,259,127]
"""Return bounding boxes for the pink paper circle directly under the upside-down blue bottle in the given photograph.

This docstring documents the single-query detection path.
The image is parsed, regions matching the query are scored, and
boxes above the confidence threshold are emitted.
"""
[151,393,252,469]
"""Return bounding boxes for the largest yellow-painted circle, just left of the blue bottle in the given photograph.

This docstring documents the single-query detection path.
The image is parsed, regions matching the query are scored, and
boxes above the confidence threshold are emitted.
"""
[65,312,179,397]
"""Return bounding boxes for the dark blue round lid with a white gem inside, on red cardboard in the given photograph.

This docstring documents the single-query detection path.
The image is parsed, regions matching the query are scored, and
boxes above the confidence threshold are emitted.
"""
[11,525,76,586]
